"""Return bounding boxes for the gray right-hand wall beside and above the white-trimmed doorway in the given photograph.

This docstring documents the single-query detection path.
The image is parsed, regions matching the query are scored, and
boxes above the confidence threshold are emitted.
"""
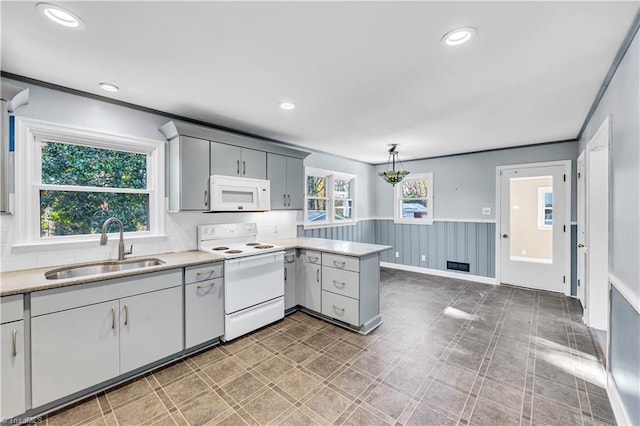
[580,17,640,425]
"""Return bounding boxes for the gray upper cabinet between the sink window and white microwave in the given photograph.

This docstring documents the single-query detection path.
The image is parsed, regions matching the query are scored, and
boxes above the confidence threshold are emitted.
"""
[169,136,209,211]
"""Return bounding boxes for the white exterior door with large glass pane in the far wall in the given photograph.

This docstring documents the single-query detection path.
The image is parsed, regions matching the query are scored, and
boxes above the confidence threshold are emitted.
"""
[498,162,571,294]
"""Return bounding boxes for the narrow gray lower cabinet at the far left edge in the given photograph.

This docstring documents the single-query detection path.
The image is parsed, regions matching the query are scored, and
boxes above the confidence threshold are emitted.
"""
[0,295,26,419]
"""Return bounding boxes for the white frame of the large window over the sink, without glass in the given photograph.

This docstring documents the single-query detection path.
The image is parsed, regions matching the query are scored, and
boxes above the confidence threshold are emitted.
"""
[14,117,166,248]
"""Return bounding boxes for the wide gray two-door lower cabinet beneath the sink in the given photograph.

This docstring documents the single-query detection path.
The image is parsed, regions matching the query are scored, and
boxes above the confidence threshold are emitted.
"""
[31,269,183,408]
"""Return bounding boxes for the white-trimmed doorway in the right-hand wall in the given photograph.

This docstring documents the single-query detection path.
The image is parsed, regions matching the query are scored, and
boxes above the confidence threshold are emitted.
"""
[577,117,611,331]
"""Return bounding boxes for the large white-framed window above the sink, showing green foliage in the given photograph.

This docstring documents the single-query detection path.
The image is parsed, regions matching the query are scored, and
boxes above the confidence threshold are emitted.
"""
[16,119,164,245]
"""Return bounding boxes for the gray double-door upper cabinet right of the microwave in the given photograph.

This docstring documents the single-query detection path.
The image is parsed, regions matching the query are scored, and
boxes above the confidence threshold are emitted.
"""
[267,153,304,210]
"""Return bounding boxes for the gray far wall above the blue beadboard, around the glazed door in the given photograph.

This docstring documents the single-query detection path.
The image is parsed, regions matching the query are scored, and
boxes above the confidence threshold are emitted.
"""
[373,141,578,222]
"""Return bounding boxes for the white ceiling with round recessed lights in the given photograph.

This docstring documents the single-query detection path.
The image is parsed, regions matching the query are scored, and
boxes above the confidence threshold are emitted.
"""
[1,0,639,163]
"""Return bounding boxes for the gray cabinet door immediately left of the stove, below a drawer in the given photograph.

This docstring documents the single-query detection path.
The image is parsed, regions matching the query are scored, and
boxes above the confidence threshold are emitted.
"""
[185,278,224,348]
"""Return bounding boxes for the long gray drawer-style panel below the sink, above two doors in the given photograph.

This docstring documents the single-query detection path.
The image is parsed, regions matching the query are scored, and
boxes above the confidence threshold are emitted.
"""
[31,268,182,317]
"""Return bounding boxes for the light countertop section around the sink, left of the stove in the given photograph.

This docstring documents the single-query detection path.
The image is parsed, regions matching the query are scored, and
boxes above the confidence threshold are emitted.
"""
[0,250,224,296]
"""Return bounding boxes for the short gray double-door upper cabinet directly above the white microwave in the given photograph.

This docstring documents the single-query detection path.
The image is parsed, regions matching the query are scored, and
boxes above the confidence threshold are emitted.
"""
[211,142,267,179]
